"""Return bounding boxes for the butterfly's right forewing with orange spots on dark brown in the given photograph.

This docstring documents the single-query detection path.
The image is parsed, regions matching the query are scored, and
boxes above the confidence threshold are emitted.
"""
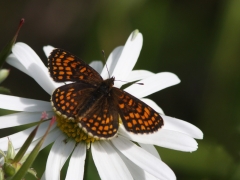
[113,88,163,134]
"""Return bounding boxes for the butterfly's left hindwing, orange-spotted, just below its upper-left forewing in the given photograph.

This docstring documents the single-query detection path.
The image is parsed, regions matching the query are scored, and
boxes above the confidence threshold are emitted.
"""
[51,82,95,119]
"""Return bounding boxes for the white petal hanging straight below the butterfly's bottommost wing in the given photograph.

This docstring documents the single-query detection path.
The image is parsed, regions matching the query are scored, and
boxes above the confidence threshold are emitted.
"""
[91,142,132,180]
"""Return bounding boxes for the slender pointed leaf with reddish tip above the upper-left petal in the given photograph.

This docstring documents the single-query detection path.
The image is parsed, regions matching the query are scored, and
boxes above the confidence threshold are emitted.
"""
[0,19,24,67]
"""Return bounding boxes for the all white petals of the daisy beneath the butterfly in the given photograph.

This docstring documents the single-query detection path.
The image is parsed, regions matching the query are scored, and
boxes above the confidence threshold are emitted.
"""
[0,31,203,180]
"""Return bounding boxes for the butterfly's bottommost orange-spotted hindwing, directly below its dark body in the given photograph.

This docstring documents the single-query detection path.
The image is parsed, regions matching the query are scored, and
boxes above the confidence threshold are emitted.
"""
[78,97,119,139]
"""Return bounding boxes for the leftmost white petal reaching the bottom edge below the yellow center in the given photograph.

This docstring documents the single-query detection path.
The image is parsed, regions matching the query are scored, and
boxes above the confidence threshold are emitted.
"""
[45,134,75,180]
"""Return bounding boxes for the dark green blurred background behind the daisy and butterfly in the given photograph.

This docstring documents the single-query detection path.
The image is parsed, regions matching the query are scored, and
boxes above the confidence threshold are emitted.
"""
[0,0,240,180]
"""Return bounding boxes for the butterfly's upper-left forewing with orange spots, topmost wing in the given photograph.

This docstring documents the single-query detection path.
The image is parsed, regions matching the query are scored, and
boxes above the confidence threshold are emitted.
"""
[48,49,103,84]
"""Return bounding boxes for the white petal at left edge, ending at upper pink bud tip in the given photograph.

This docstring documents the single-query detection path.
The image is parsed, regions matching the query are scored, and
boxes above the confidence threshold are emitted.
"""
[0,112,54,129]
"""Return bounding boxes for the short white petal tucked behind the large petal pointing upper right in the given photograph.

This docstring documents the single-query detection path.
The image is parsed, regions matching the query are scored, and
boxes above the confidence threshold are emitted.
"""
[126,70,154,82]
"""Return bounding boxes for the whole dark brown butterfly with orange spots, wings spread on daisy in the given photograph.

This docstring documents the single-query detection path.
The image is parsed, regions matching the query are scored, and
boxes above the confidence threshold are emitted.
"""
[48,49,163,139]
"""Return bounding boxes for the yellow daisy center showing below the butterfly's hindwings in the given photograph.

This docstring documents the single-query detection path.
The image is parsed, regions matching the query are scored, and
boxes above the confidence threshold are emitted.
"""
[56,115,99,144]
